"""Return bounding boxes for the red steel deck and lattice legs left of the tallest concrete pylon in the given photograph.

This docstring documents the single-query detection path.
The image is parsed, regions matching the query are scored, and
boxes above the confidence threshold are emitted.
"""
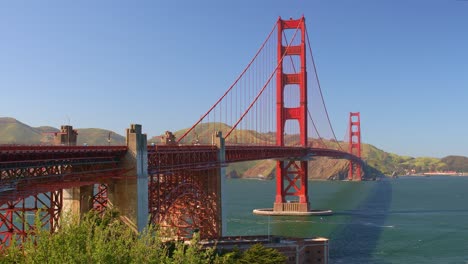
[0,146,127,247]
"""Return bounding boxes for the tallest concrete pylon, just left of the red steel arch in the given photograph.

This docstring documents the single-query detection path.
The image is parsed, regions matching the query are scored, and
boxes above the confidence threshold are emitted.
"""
[108,124,149,231]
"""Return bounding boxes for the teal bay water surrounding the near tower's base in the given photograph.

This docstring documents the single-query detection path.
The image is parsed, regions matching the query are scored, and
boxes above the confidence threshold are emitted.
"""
[226,177,468,263]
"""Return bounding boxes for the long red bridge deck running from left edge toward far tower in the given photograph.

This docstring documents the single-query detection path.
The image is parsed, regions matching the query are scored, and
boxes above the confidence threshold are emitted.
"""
[0,145,362,202]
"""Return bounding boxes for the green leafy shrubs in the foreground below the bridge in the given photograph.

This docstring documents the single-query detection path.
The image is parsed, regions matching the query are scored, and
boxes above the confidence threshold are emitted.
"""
[0,211,286,264]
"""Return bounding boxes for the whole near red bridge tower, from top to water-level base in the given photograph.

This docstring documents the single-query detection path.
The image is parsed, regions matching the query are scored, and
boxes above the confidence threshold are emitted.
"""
[273,17,309,212]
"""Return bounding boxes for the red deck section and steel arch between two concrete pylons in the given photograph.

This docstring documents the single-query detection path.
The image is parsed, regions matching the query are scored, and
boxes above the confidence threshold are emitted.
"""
[148,145,221,238]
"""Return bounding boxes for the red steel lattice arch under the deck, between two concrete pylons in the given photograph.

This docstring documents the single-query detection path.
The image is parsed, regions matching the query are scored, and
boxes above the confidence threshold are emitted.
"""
[149,169,221,238]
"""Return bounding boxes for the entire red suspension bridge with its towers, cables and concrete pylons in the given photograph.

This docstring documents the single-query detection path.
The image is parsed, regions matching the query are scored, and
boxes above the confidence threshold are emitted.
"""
[0,17,363,248]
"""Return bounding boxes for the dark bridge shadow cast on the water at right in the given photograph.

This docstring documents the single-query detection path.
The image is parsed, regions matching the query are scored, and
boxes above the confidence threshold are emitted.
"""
[330,181,392,263]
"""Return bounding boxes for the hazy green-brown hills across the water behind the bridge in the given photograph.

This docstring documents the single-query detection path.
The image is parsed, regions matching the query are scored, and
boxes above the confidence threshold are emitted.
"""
[0,117,468,179]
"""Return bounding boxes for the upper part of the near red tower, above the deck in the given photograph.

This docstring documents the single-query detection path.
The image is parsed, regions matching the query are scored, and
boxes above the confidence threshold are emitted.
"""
[276,17,307,147]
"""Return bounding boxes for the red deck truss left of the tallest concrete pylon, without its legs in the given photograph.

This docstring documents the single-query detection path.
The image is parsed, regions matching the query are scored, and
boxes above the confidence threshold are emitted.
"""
[0,146,127,205]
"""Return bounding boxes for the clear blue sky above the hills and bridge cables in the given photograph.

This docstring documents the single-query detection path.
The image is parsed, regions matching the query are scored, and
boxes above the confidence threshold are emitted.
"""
[0,0,468,157]
